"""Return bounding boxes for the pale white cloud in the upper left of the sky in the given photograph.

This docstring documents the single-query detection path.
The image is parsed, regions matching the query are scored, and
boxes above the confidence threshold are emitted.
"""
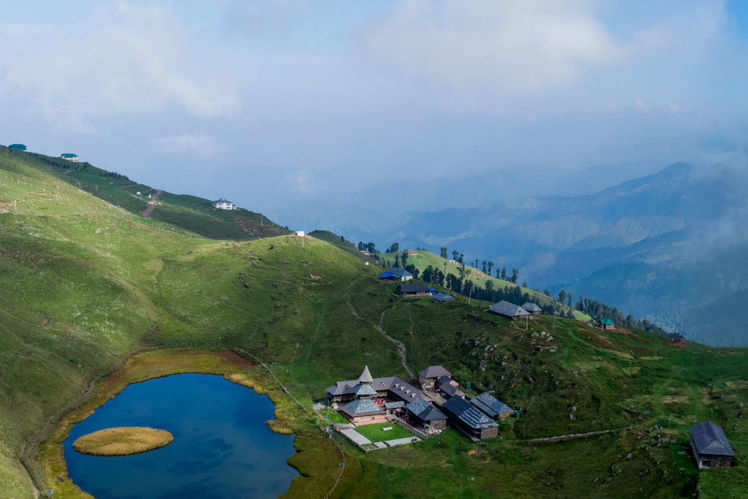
[0,2,239,132]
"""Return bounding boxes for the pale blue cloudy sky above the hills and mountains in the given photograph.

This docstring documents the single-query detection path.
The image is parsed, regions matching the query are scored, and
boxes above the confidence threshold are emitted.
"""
[0,0,748,230]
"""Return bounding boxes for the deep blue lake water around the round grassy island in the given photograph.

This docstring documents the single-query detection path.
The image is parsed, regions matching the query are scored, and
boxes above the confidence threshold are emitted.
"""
[63,374,298,499]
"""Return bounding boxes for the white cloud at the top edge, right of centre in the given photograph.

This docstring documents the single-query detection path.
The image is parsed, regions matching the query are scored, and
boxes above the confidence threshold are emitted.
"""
[367,0,622,93]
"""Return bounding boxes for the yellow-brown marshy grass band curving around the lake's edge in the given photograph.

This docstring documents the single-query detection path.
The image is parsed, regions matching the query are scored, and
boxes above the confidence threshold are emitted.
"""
[29,349,309,498]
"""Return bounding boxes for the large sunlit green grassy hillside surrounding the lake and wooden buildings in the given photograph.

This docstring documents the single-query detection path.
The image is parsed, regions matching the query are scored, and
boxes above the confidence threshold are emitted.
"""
[0,150,748,497]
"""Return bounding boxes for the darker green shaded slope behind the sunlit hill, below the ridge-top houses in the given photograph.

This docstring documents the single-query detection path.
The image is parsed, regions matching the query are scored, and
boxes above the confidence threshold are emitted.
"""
[24,153,288,240]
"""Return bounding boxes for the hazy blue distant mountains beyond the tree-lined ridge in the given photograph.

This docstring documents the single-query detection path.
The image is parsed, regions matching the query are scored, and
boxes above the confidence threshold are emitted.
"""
[360,163,748,345]
